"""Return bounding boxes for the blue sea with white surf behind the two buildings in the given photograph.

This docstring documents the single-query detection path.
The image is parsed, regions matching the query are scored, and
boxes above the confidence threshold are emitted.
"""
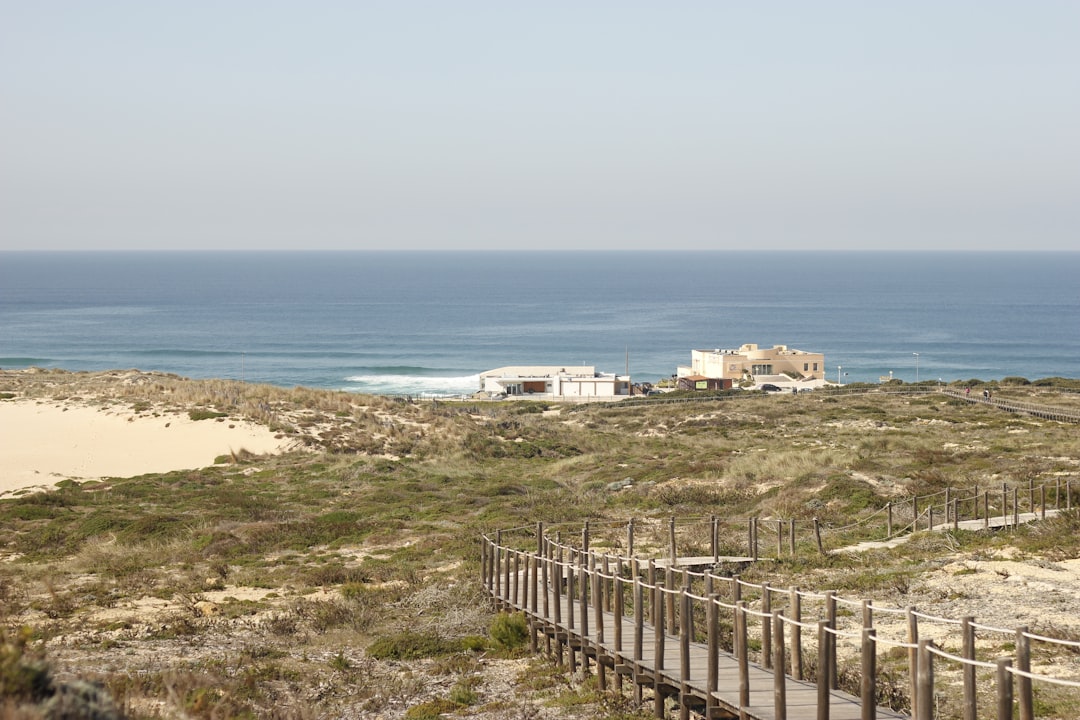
[0,252,1080,396]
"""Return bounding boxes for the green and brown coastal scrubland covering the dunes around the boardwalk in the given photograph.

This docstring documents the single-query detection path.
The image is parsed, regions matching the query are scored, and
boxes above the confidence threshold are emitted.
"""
[0,370,1080,720]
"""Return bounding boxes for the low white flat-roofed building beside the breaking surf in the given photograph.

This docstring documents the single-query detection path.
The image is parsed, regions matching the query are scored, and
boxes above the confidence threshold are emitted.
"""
[480,365,630,398]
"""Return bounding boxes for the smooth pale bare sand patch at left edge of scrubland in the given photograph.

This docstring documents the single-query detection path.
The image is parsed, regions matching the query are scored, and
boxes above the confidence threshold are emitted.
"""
[0,399,289,497]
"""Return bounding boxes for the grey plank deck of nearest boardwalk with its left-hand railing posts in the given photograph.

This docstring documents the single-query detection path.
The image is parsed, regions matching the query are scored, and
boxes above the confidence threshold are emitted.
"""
[484,545,907,720]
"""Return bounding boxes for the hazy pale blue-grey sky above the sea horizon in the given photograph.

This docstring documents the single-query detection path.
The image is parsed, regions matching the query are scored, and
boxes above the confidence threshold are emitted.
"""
[0,0,1080,249]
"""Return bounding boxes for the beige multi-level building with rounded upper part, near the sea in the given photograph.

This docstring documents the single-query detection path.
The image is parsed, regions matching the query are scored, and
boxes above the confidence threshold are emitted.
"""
[676,344,825,384]
